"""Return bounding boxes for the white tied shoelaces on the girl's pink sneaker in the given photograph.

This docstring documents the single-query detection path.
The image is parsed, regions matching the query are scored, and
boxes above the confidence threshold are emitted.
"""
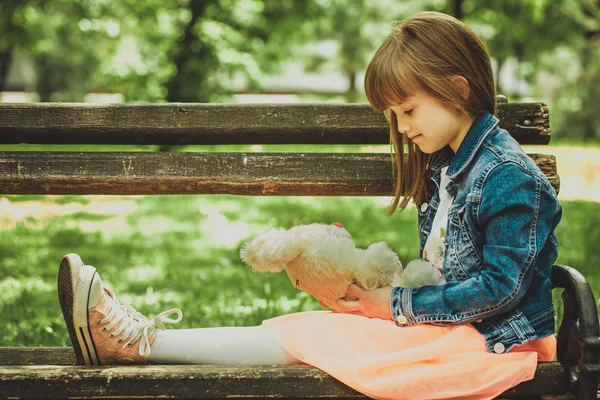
[98,293,183,357]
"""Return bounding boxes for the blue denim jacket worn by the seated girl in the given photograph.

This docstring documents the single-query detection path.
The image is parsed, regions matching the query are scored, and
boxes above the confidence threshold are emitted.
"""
[390,111,562,353]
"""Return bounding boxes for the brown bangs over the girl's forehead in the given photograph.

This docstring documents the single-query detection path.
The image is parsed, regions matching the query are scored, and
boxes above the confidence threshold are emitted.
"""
[365,37,421,111]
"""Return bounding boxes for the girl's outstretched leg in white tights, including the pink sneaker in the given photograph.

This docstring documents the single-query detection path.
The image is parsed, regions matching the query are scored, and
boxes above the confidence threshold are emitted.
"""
[58,254,295,365]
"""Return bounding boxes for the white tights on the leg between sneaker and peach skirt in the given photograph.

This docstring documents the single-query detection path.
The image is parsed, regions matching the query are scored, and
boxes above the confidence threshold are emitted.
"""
[150,326,298,365]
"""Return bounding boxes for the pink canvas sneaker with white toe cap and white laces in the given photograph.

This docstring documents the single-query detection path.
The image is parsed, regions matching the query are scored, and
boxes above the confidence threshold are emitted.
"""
[58,254,183,365]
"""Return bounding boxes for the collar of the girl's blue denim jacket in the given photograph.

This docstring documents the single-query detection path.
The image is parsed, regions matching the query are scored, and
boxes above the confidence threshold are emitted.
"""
[447,111,498,180]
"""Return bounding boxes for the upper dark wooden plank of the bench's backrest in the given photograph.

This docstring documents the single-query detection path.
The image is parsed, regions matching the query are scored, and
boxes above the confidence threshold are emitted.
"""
[0,103,550,145]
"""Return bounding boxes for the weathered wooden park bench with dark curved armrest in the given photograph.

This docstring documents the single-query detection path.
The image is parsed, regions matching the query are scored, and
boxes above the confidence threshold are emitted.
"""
[0,103,600,399]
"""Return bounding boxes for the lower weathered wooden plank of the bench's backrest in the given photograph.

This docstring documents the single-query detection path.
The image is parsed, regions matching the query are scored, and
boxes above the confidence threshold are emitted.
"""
[0,152,559,196]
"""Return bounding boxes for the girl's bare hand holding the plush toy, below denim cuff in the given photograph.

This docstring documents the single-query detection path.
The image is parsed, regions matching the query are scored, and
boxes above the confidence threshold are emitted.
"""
[336,284,392,320]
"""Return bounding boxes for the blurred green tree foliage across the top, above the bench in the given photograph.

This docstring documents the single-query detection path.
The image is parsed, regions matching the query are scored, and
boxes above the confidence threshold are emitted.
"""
[0,0,600,139]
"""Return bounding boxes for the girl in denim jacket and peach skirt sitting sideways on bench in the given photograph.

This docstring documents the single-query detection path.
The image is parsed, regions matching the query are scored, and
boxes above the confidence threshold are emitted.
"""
[59,12,561,399]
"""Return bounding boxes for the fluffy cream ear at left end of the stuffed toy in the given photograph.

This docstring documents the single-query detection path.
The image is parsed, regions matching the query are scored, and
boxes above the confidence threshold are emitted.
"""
[240,228,299,272]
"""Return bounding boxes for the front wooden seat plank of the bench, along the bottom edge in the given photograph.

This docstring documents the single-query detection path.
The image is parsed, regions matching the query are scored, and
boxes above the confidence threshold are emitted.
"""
[0,362,565,399]
